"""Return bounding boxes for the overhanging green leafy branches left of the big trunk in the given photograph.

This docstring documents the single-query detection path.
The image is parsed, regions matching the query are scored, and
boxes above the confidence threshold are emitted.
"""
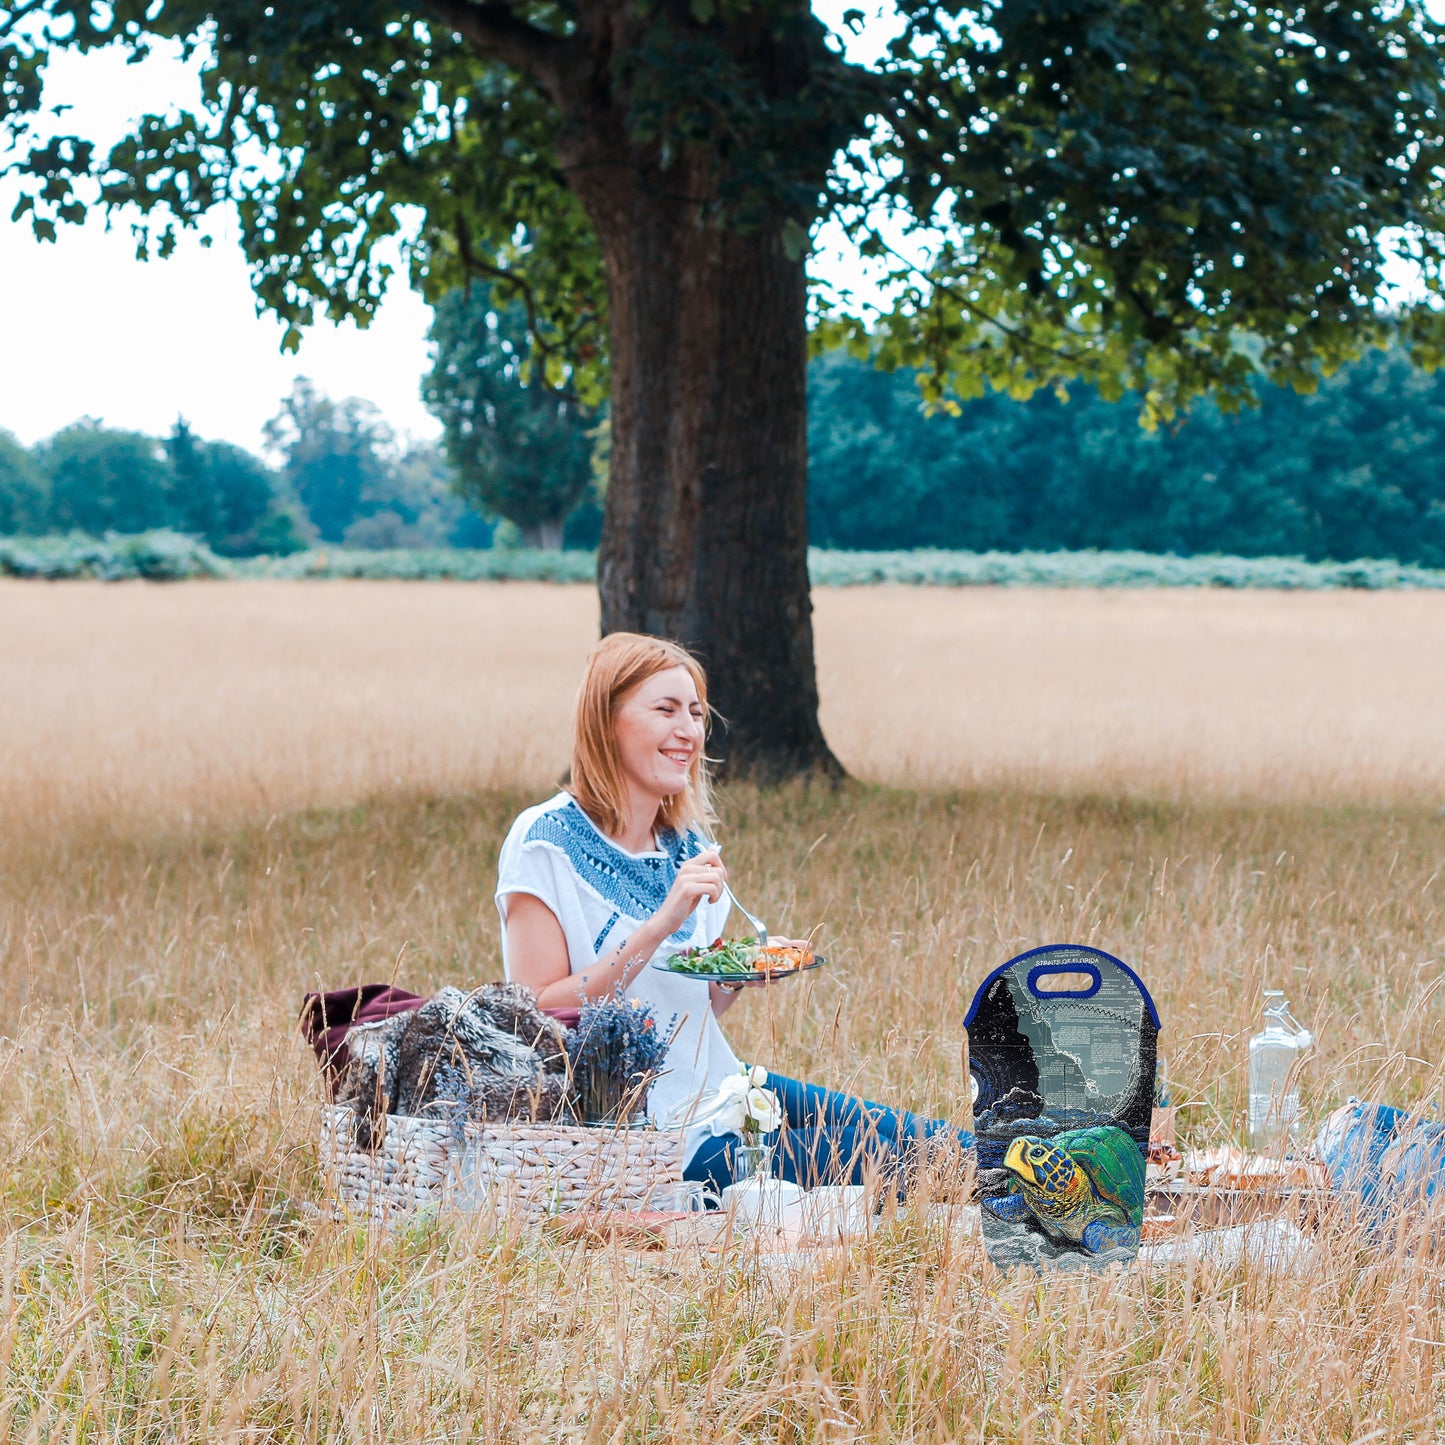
[0,0,607,390]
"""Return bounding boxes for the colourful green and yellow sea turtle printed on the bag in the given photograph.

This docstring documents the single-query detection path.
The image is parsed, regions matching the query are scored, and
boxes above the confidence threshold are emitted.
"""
[984,1126,1144,1254]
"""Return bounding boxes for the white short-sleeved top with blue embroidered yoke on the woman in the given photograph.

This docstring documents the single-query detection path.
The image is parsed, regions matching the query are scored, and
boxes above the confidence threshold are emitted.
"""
[497,792,740,1159]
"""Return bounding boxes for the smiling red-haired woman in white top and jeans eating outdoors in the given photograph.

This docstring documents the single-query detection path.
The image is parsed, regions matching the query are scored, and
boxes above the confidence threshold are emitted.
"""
[497,633,972,1188]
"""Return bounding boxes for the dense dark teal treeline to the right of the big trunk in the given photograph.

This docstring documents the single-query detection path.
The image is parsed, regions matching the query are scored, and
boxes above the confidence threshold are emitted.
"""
[809,350,1445,568]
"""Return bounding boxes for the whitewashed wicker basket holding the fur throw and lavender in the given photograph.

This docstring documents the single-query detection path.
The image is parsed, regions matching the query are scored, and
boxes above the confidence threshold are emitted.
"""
[321,1104,682,1221]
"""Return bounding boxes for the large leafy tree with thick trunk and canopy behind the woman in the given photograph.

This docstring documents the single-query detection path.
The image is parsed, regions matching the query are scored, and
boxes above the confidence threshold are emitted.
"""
[8,0,1445,775]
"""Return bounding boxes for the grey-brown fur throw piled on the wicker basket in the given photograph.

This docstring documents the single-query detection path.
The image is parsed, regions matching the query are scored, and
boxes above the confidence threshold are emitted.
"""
[337,984,566,1149]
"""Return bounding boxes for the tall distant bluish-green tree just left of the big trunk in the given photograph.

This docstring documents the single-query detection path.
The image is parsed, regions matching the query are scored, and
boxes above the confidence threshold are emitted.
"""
[423,283,595,548]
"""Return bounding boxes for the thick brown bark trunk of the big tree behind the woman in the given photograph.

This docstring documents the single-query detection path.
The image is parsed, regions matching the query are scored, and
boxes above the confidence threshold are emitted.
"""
[557,146,842,782]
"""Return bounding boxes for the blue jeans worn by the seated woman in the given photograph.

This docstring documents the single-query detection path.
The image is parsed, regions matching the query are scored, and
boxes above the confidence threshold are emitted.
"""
[682,1074,974,1189]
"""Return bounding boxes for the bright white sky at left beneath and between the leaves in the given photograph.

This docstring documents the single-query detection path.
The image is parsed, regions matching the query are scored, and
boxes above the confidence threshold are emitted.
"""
[0,0,889,449]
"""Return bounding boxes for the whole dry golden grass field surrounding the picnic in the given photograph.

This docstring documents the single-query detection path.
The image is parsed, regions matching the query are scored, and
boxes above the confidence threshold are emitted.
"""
[0,584,1445,1442]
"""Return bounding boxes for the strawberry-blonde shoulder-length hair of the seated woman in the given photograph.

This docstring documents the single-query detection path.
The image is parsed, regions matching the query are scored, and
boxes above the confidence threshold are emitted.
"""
[568,633,715,835]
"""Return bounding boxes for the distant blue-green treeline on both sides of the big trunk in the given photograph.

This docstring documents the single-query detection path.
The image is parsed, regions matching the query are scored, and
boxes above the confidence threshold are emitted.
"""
[8,341,1445,568]
